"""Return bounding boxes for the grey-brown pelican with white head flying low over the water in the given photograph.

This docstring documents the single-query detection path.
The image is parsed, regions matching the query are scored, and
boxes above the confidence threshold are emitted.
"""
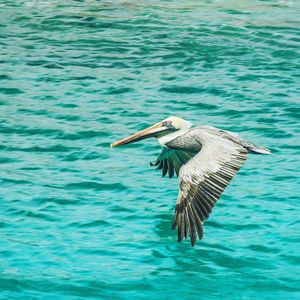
[111,116,271,246]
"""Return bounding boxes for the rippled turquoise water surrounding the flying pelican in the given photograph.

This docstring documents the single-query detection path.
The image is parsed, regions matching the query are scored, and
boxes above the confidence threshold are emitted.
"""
[0,0,300,299]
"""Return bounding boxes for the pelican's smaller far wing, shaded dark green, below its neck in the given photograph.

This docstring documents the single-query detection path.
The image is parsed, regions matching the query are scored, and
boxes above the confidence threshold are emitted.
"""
[150,147,195,178]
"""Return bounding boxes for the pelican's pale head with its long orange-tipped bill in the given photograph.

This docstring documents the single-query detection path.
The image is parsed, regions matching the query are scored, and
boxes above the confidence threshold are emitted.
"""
[110,117,192,147]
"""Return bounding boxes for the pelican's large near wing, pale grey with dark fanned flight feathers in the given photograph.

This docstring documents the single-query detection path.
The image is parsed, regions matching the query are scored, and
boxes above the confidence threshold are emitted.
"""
[172,136,248,246]
